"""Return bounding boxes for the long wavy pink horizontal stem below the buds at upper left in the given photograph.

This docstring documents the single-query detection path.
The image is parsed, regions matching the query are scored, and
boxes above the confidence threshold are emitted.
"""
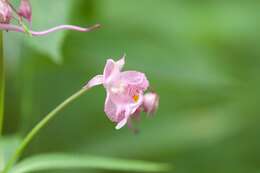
[0,24,101,36]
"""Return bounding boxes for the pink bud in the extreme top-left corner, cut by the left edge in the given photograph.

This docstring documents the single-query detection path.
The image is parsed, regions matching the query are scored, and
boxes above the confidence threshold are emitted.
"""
[0,0,12,24]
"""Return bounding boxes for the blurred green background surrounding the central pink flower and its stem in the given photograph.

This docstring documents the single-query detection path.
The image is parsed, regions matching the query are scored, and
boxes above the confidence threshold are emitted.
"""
[4,0,260,173]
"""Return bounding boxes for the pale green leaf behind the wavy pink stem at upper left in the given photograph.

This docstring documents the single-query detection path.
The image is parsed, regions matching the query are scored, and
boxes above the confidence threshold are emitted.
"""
[22,0,73,63]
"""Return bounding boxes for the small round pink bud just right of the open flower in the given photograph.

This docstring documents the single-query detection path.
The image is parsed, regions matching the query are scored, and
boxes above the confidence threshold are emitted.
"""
[143,92,159,114]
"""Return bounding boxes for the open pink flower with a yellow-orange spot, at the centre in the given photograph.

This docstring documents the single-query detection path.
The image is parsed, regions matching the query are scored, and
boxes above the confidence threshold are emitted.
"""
[85,57,149,129]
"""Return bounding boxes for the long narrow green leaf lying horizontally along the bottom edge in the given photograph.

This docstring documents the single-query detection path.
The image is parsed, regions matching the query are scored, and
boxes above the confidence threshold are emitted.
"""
[11,154,169,173]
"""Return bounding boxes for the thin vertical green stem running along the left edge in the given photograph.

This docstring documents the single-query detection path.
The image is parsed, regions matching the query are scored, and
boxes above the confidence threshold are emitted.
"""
[0,31,5,136]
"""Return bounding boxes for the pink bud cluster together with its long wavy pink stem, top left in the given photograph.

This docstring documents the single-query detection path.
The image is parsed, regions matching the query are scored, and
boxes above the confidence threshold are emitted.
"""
[0,0,100,36]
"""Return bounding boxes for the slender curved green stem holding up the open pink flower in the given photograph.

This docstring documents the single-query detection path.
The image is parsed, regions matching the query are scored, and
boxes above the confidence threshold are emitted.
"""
[2,88,88,173]
